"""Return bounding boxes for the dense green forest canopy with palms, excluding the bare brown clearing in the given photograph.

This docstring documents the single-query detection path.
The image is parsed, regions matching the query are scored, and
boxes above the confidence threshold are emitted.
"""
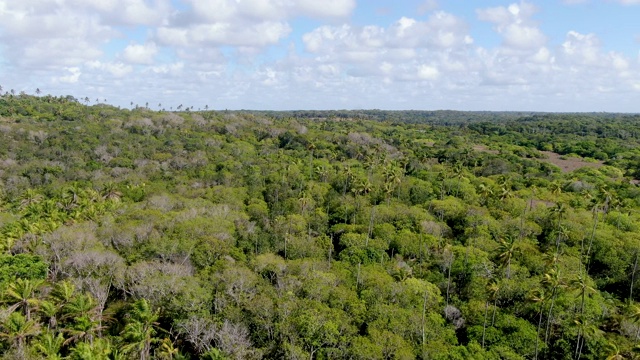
[0,94,640,359]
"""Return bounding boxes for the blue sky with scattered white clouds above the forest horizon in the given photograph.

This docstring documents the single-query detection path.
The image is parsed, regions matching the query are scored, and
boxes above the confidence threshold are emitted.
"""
[0,0,640,113]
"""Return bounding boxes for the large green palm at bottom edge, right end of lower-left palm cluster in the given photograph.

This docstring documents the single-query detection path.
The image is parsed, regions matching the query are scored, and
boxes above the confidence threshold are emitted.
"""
[122,299,158,360]
